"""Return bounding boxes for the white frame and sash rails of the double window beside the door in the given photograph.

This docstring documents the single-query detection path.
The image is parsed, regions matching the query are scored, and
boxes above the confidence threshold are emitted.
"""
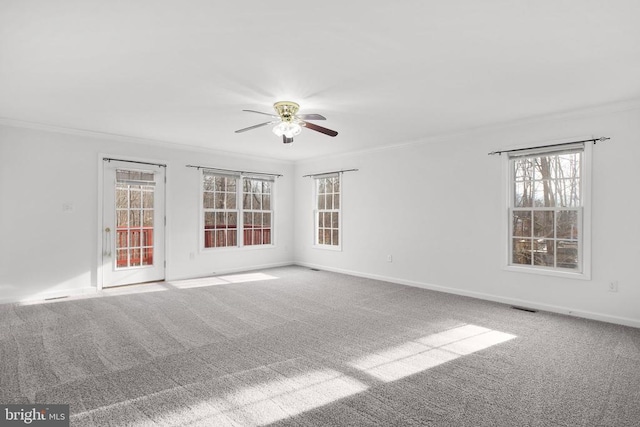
[198,169,276,252]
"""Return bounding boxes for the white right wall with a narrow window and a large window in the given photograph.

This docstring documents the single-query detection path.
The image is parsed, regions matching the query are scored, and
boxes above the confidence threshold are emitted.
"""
[294,104,640,326]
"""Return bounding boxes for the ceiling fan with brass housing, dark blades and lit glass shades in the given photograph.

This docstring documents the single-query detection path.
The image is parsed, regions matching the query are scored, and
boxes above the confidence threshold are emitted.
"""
[236,101,338,144]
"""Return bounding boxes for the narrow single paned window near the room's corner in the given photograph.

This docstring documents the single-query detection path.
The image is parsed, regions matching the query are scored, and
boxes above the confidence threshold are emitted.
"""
[314,174,341,248]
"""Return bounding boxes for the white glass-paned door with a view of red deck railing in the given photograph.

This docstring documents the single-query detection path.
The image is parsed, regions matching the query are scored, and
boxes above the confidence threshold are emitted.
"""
[102,160,165,287]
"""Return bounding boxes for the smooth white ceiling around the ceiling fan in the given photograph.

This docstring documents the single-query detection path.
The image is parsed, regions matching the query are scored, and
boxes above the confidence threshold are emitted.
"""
[0,0,640,160]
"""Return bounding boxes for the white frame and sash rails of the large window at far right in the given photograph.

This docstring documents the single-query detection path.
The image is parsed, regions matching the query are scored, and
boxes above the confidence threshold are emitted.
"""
[502,142,593,280]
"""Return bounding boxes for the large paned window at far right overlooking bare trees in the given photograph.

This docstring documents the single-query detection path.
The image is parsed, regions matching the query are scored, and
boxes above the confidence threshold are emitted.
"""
[509,144,588,273]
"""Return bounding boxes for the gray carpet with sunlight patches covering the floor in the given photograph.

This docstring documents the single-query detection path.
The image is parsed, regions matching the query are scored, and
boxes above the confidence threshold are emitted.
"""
[0,267,640,427]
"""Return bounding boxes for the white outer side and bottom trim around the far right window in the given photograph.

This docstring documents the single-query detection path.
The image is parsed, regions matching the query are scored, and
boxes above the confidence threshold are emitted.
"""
[502,142,593,280]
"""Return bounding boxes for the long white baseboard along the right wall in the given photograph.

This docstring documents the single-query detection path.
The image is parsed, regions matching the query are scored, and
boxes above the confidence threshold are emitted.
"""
[294,262,640,328]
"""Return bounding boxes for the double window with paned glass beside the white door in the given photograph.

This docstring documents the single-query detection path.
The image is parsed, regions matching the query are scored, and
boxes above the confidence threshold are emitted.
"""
[202,171,273,248]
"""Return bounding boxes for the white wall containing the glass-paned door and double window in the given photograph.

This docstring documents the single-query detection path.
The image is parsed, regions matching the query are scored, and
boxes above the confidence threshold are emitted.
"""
[0,126,293,302]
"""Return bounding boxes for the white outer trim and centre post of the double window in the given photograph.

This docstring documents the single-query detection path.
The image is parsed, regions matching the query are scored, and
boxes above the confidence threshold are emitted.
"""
[198,171,277,253]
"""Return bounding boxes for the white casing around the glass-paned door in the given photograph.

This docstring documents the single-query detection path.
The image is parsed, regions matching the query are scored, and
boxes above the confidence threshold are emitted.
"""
[95,153,169,291]
